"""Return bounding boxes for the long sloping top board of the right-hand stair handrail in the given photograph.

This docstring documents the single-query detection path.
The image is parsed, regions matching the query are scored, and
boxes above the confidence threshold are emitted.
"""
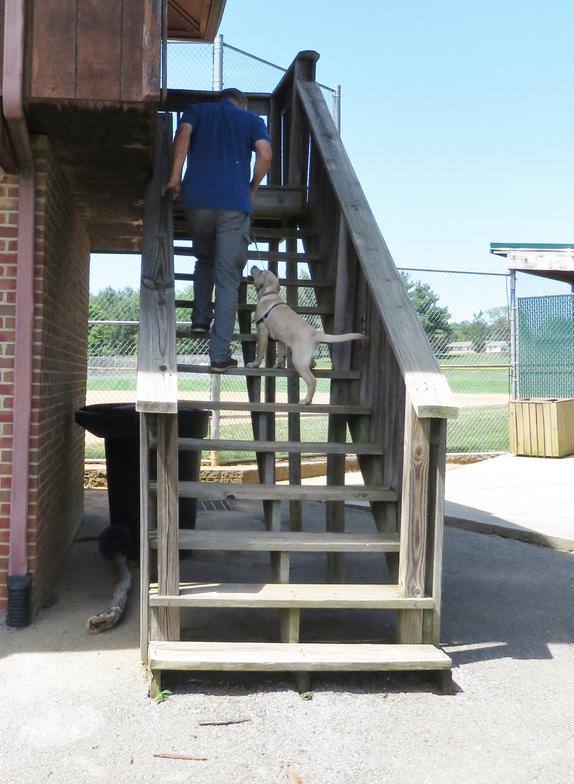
[295,80,458,419]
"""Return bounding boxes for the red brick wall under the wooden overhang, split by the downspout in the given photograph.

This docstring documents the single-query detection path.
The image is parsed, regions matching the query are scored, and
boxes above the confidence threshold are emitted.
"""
[0,137,89,612]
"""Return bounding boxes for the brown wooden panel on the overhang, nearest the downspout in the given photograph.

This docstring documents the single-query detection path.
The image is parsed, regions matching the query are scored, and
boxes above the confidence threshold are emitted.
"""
[28,0,77,98]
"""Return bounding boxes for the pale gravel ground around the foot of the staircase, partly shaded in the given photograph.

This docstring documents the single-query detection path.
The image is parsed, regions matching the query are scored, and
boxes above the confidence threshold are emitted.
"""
[0,491,574,784]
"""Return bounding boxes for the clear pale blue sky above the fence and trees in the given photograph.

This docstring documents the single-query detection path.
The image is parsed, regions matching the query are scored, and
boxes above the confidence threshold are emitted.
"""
[92,0,574,318]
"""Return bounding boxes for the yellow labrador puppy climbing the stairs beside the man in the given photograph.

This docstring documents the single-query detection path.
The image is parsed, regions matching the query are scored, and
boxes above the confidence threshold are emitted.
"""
[247,267,367,405]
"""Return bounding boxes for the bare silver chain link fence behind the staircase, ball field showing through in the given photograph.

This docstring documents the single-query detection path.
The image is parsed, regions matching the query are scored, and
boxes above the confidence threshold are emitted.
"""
[86,41,524,459]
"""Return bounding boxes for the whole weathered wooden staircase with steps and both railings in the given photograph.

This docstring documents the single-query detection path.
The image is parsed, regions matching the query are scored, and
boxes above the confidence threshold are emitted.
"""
[138,52,456,692]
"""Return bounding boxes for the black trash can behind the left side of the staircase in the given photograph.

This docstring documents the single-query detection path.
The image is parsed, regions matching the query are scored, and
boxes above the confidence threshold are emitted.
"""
[76,401,209,551]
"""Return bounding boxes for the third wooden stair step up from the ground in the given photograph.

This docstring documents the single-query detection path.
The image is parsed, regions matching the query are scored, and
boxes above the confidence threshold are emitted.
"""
[150,529,399,553]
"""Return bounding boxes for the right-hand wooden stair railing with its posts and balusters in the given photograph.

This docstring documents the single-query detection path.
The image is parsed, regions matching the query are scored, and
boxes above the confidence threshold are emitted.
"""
[270,52,458,643]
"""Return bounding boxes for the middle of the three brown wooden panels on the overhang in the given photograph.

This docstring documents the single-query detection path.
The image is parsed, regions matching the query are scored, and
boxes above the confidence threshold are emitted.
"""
[76,0,123,101]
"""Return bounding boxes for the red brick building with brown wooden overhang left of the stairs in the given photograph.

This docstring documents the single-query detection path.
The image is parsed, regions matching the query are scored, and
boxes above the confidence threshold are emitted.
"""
[0,0,225,625]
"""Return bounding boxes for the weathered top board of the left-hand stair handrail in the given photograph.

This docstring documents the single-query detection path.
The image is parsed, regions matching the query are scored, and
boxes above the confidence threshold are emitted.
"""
[136,114,177,414]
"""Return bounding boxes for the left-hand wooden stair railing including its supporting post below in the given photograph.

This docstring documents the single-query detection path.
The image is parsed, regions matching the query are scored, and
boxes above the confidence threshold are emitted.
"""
[136,113,179,663]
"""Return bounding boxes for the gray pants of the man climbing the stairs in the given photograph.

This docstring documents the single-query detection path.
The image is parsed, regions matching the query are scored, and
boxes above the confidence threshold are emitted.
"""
[184,209,251,362]
